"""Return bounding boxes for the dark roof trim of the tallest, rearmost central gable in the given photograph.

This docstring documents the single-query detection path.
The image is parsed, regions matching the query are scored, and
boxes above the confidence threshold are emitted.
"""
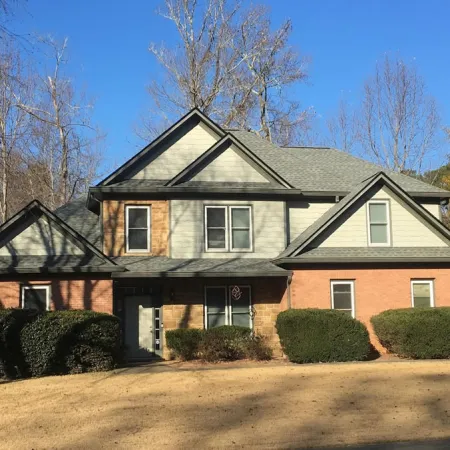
[97,108,225,186]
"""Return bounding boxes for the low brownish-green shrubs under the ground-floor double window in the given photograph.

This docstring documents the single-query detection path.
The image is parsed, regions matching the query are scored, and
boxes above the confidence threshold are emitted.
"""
[166,325,272,362]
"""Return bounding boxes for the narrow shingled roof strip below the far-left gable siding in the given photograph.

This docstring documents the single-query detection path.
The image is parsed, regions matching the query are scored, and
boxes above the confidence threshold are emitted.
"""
[0,254,120,273]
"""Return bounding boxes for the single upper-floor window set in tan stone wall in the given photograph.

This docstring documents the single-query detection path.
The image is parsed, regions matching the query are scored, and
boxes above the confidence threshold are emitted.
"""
[126,206,150,252]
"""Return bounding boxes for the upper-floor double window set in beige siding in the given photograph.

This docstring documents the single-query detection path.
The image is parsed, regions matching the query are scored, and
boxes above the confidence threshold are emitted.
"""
[205,206,252,252]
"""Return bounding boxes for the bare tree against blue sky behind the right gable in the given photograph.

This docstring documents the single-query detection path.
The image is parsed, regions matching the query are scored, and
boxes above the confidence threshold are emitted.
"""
[357,56,440,173]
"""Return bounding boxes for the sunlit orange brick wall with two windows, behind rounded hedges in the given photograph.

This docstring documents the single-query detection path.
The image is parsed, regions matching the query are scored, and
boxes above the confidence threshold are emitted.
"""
[291,268,450,352]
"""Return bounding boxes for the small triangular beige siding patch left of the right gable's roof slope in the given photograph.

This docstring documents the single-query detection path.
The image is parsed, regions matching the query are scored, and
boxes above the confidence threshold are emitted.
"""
[287,201,334,242]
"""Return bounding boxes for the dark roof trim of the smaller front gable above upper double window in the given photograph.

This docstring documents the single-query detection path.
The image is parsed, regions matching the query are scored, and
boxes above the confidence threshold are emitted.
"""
[166,133,292,188]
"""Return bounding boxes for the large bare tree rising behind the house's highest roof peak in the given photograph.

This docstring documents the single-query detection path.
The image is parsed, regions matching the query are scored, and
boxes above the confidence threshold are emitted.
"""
[147,0,309,144]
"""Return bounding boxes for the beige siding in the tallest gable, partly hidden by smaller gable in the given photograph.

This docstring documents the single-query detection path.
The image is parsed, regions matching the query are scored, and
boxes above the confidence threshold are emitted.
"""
[133,122,218,180]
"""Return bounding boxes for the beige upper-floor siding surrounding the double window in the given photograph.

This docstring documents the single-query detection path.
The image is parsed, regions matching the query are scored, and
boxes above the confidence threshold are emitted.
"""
[170,200,286,258]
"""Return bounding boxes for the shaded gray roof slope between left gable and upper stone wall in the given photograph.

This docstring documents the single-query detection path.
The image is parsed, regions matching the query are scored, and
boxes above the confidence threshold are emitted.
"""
[54,197,102,250]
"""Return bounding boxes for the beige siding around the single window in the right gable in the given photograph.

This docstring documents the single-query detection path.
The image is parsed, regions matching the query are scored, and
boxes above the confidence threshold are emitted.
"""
[320,188,449,247]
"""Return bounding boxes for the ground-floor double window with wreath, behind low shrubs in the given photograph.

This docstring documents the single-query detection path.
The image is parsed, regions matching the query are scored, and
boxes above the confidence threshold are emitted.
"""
[205,286,252,328]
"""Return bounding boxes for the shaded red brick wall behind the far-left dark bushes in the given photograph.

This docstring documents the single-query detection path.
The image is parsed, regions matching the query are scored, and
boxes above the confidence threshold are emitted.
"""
[0,279,113,314]
